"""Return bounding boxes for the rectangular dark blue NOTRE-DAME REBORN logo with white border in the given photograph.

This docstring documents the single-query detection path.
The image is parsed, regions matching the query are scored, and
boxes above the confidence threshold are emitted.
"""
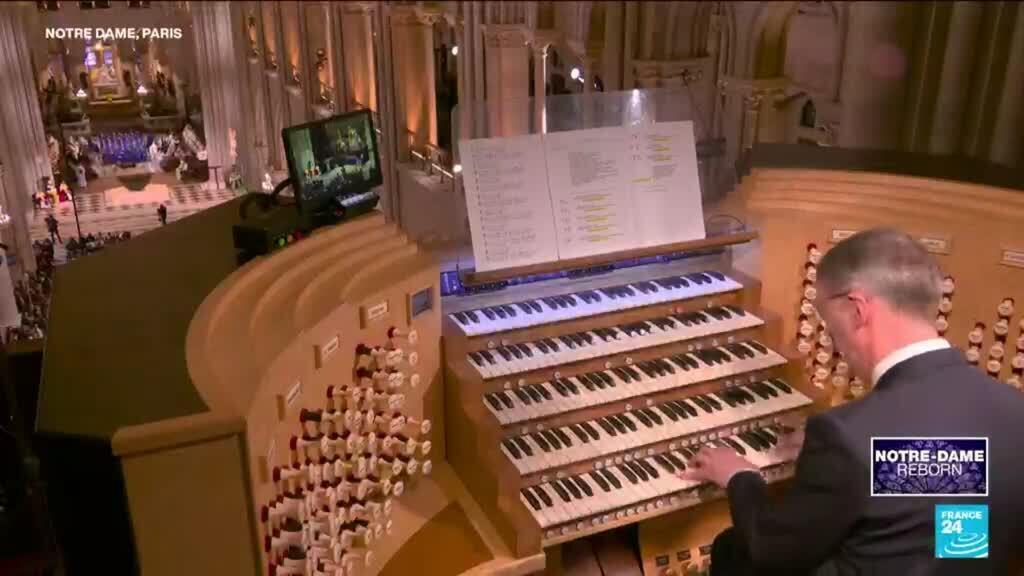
[871,438,988,496]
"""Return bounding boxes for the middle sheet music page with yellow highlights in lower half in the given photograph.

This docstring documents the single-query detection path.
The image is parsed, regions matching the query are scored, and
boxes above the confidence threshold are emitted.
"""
[544,127,636,259]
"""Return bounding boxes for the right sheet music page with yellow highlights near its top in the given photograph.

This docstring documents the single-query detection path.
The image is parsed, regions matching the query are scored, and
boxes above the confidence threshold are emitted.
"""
[628,121,707,247]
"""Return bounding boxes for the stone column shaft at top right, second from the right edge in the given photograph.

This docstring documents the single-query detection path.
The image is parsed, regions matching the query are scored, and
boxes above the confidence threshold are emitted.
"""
[928,2,985,155]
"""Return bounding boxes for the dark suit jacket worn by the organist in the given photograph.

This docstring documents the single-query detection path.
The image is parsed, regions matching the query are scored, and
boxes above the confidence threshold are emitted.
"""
[728,348,1024,576]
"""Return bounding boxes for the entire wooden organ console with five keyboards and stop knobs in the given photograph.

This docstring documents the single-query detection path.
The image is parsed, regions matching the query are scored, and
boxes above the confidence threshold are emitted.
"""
[39,147,1024,576]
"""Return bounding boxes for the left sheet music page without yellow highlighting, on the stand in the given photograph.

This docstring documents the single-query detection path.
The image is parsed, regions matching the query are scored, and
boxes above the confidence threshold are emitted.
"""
[459,134,558,272]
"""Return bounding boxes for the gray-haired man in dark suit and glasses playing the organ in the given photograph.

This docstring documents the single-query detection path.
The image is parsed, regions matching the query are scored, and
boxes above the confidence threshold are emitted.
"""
[686,229,1024,576]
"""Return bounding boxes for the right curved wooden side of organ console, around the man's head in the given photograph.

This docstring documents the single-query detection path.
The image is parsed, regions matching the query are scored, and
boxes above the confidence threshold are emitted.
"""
[640,145,1024,576]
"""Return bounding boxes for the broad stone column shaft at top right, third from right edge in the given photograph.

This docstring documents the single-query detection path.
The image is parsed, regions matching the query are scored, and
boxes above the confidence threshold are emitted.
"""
[839,2,913,150]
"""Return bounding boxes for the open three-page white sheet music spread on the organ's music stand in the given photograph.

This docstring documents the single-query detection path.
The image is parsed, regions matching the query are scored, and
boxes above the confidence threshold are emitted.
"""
[459,122,706,272]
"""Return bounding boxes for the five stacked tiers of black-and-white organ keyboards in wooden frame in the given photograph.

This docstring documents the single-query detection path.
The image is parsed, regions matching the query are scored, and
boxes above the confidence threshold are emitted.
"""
[442,234,813,556]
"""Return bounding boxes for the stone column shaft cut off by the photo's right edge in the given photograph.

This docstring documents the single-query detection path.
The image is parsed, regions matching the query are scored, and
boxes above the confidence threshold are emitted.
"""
[988,7,1024,166]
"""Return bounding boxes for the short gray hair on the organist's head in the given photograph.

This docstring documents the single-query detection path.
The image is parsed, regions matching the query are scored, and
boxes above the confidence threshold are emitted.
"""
[818,228,942,323]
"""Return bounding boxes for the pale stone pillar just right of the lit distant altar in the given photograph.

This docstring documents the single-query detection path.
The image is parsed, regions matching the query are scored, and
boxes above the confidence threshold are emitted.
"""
[193,2,262,189]
